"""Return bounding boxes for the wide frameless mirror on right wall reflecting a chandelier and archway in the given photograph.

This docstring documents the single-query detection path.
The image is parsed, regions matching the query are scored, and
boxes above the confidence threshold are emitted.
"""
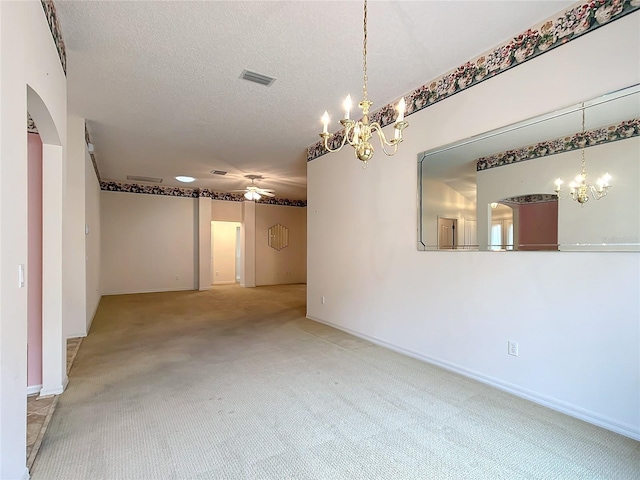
[418,85,640,251]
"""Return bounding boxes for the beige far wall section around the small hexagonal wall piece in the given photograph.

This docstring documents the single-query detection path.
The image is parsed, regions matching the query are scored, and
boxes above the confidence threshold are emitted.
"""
[256,203,307,285]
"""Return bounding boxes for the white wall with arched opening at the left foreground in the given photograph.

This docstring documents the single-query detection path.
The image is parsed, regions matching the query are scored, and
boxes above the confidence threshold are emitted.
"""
[0,1,67,479]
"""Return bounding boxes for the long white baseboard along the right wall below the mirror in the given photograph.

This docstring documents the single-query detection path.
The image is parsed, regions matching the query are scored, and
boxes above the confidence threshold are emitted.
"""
[307,315,640,441]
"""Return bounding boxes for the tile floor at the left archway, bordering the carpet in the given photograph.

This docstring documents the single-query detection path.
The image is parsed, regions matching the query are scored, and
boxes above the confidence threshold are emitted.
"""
[27,338,82,468]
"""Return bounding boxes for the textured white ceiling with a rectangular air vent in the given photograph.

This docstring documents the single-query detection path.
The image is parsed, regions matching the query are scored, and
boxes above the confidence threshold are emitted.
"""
[56,0,574,199]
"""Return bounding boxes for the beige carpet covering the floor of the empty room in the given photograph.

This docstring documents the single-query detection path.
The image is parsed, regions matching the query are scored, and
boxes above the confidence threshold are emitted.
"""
[32,285,640,480]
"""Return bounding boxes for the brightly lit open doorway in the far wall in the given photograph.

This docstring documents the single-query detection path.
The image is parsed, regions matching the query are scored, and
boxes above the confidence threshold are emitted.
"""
[211,221,242,285]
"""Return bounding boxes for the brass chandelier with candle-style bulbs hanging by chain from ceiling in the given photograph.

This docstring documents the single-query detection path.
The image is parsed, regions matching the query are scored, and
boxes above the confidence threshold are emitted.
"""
[320,0,409,167]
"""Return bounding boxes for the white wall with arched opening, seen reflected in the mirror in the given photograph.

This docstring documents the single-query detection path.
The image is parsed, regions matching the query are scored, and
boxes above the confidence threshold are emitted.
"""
[477,137,640,250]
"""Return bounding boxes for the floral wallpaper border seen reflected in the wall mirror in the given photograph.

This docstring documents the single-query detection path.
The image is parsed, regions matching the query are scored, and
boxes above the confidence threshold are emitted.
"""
[476,118,640,172]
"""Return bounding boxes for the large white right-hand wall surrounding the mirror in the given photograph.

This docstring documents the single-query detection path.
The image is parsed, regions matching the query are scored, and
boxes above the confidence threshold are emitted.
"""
[307,13,640,439]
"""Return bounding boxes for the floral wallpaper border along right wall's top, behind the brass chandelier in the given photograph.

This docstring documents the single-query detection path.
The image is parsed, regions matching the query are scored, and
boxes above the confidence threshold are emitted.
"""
[307,0,640,162]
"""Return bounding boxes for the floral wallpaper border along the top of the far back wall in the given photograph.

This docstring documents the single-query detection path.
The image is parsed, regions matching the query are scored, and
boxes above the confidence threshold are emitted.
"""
[100,181,307,207]
